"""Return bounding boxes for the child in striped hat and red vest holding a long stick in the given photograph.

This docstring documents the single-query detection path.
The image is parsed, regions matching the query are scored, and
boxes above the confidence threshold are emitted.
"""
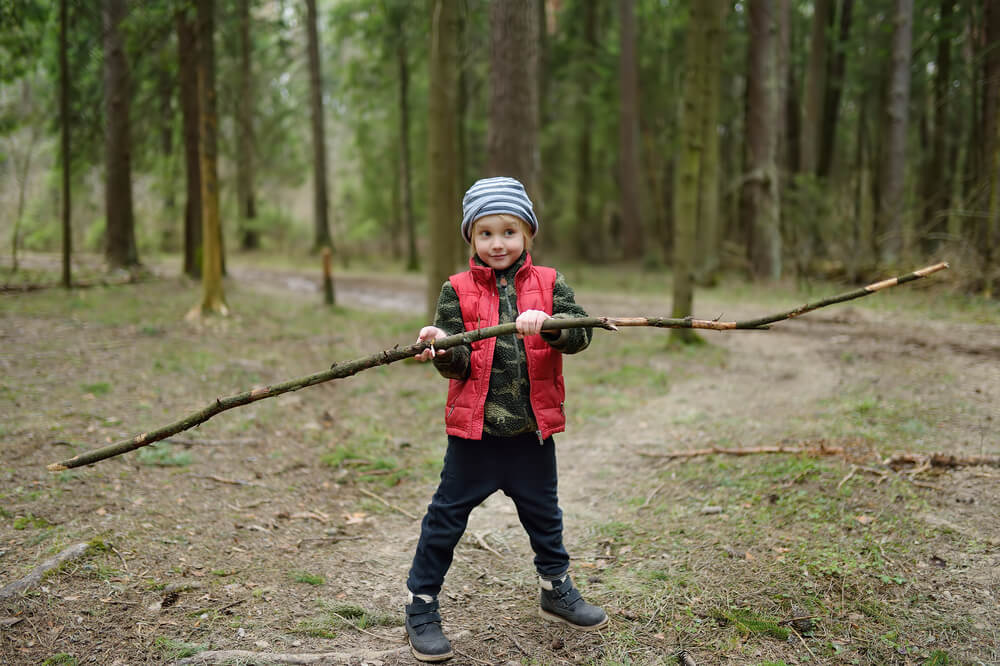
[406,178,608,661]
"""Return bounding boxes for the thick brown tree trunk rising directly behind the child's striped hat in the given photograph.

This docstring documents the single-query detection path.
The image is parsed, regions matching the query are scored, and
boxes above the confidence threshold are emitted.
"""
[486,0,541,200]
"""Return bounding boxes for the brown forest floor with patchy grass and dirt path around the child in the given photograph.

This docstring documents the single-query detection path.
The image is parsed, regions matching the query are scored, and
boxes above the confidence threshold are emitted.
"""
[0,252,1000,666]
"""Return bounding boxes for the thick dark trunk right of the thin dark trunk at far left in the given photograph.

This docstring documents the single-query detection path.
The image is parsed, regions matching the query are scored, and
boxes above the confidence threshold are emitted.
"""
[103,0,139,268]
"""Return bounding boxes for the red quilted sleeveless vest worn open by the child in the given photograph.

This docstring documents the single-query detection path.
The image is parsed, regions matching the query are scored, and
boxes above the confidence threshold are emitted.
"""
[445,255,566,439]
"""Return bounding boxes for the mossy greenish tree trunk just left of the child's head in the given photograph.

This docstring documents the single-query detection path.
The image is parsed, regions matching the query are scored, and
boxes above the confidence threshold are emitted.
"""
[427,0,461,320]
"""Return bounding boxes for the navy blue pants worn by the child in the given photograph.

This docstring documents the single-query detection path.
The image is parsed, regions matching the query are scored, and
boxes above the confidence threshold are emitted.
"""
[406,433,569,596]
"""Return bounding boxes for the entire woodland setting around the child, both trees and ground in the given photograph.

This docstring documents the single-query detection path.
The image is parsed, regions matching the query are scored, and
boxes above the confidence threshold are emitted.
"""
[0,0,1000,666]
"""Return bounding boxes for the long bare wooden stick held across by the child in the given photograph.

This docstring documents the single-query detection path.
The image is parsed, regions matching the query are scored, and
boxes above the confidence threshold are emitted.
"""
[48,263,948,472]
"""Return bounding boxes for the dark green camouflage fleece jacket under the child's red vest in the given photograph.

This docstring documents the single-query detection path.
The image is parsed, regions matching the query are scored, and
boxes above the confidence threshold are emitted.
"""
[434,254,593,437]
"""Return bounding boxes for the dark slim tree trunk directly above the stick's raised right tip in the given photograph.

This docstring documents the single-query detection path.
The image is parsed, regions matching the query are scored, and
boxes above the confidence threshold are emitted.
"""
[921,0,955,255]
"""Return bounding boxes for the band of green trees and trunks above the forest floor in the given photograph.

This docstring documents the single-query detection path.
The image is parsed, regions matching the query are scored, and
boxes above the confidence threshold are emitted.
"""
[0,0,1000,306]
